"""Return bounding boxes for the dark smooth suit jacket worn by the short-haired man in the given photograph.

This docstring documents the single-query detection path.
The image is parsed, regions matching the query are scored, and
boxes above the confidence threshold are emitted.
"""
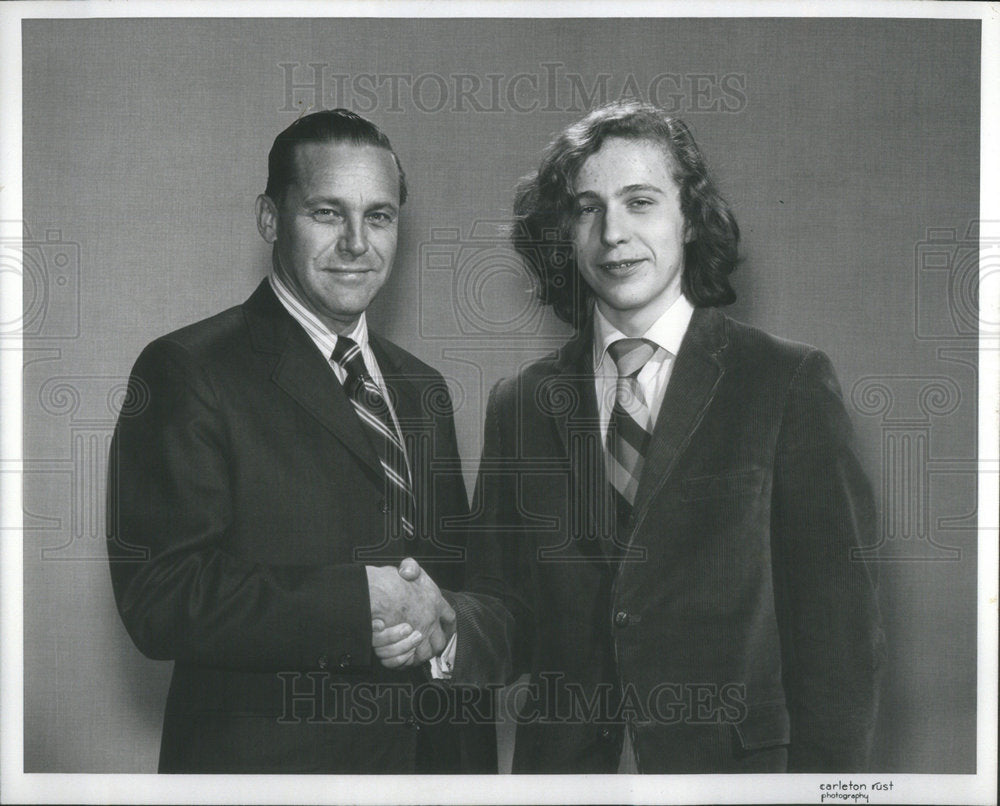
[108,281,496,772]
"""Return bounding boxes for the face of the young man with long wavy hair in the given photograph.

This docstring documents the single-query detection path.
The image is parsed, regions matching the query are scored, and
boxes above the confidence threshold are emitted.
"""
[571,138,688,336]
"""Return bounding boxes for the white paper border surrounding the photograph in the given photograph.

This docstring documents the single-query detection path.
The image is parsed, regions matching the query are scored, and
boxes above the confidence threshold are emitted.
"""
[0,0,1000,804]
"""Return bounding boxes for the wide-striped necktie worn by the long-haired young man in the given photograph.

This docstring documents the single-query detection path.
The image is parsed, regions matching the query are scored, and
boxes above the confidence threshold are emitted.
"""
[605,339,656,508]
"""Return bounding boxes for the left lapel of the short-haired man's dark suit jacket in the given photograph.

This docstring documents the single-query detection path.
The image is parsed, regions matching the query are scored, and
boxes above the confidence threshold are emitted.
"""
[243,280,383,478]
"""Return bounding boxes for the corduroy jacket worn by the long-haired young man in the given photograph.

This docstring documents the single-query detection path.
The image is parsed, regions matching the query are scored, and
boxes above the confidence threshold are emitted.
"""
[453,309,884,773]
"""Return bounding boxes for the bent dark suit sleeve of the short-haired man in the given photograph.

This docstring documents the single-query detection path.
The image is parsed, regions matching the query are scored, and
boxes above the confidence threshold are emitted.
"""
[108,339,371,671]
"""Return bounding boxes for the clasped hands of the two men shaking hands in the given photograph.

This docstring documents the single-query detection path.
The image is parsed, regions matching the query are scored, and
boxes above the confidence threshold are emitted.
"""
[365,557,455,669]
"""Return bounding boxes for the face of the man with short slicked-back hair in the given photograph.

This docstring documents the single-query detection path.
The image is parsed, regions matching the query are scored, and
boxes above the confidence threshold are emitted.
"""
[257,143,399,332]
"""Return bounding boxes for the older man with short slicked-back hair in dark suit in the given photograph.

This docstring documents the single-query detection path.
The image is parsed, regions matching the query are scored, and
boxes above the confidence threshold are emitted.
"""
[108,110,496,773]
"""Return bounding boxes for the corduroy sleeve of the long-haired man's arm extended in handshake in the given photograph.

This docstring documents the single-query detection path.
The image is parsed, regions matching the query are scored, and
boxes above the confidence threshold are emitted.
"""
[449,381,533,685]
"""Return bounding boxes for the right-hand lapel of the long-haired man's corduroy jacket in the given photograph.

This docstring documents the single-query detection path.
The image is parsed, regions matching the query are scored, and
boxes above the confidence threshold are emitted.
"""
[634,308,726,523]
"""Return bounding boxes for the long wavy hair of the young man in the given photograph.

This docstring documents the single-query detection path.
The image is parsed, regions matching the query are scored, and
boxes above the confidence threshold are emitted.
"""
[512,101,740,328]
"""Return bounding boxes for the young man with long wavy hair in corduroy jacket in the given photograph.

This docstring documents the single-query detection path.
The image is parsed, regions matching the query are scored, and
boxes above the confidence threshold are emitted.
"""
[375,103,884,773]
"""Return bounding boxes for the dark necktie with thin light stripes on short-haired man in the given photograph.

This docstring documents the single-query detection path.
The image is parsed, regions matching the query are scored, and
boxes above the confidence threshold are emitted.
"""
[330,336,415,538]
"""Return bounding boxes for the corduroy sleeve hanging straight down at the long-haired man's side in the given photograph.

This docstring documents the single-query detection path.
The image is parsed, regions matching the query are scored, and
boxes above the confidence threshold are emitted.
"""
[772,351,885,772]
